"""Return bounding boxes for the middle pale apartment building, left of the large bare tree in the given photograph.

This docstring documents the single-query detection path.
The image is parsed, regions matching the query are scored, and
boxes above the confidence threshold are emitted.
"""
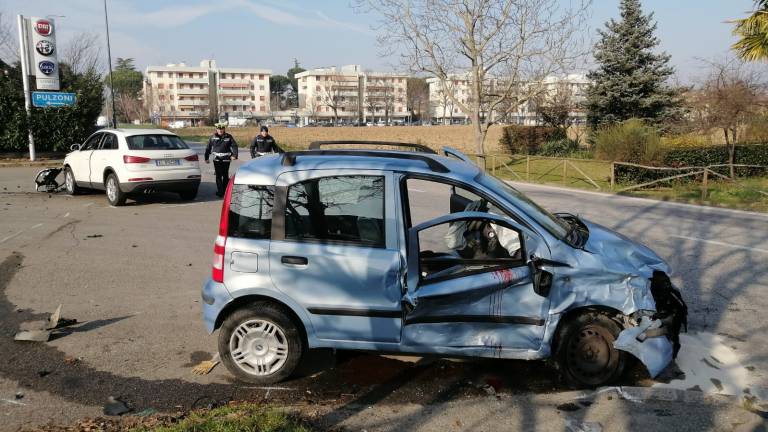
[296,65,409,123]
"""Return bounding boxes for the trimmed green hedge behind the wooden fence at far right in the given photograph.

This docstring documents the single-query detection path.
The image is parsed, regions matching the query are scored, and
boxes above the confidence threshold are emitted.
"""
[616,143,768,183]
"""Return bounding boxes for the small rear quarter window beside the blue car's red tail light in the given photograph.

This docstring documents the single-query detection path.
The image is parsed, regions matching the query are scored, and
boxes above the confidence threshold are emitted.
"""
[228,185,275,240]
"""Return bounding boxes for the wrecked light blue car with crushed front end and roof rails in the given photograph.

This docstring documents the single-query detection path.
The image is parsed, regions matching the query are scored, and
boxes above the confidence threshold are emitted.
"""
[202,141,687,387]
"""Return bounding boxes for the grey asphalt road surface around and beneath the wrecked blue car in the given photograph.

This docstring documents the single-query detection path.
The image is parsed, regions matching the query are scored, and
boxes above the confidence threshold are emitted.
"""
[0,156,768,431]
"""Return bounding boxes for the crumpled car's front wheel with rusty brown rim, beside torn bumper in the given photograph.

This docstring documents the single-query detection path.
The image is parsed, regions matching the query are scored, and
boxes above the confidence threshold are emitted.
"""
[555,312,627,388]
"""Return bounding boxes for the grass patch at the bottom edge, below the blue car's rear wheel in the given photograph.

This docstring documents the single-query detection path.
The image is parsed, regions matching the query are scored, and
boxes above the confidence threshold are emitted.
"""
[132,404,311,432]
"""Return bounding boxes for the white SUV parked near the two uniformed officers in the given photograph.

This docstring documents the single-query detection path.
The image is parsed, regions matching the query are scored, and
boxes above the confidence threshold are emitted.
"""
[64,129,201,206]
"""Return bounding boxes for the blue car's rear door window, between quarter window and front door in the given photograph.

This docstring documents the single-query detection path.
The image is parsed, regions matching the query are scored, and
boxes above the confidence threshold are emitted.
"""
[285,176,386,248]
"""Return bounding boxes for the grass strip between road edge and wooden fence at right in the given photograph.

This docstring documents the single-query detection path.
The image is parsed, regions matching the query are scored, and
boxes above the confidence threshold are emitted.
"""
[623,177,768,212]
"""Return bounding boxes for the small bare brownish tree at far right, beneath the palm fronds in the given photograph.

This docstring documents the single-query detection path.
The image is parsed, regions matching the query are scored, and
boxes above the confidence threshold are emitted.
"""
[689,60,765,177]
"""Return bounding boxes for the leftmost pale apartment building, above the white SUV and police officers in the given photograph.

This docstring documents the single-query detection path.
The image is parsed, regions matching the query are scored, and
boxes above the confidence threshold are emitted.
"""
[144,60,272,126]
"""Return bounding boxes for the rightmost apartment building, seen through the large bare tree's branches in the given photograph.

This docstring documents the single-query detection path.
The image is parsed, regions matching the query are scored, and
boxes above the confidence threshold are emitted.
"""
[427,74,590,126]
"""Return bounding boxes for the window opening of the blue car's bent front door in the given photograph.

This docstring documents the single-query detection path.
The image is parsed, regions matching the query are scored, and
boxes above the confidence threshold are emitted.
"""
[418,218,524,282]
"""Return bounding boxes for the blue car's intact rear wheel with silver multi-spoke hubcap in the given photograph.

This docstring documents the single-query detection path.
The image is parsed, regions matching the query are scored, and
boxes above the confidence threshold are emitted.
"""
[219,302,303,384]
